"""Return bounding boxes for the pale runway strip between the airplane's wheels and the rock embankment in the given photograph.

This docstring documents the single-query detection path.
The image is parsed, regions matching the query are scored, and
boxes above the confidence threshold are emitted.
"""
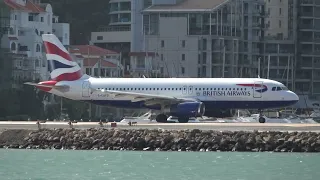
[0,121,320,132]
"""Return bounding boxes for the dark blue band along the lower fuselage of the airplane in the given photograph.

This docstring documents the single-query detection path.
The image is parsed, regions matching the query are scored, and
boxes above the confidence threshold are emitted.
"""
[86,100,297,110]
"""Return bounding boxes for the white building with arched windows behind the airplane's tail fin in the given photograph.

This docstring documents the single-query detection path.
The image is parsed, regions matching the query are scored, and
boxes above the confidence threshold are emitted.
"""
[1,0,69,81]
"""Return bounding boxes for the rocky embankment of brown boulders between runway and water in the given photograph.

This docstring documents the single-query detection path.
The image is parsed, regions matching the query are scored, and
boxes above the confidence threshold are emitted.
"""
[0,129,320,152]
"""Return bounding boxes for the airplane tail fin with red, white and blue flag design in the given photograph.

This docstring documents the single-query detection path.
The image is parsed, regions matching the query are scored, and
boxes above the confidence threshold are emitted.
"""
[42,34,82,82]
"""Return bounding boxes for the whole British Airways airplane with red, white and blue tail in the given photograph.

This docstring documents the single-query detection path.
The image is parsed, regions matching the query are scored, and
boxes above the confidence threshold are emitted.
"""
[25,34,299,123]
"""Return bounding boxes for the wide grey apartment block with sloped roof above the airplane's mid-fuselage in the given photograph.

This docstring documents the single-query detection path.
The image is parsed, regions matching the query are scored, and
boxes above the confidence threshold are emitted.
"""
[143,0,264,77]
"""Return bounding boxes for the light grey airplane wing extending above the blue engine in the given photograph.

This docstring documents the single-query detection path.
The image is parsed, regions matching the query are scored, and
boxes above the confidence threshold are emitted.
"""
[94,89,198,105]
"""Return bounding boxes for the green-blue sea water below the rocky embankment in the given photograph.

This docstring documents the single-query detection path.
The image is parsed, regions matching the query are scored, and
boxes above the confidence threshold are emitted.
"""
[0,149,320,180]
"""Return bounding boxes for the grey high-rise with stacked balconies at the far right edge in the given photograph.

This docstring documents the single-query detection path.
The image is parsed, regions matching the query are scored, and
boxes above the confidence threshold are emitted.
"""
[295,0,320,96]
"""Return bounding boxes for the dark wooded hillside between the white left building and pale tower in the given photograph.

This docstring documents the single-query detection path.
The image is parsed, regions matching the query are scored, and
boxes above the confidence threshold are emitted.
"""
[41,0,109,45]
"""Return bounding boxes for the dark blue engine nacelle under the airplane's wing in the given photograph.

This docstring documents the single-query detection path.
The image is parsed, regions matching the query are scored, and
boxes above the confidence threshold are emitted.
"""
[164,102,205,117]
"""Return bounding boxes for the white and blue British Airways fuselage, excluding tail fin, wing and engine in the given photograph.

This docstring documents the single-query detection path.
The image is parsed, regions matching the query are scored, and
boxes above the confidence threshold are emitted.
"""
[50,77,299,110]
